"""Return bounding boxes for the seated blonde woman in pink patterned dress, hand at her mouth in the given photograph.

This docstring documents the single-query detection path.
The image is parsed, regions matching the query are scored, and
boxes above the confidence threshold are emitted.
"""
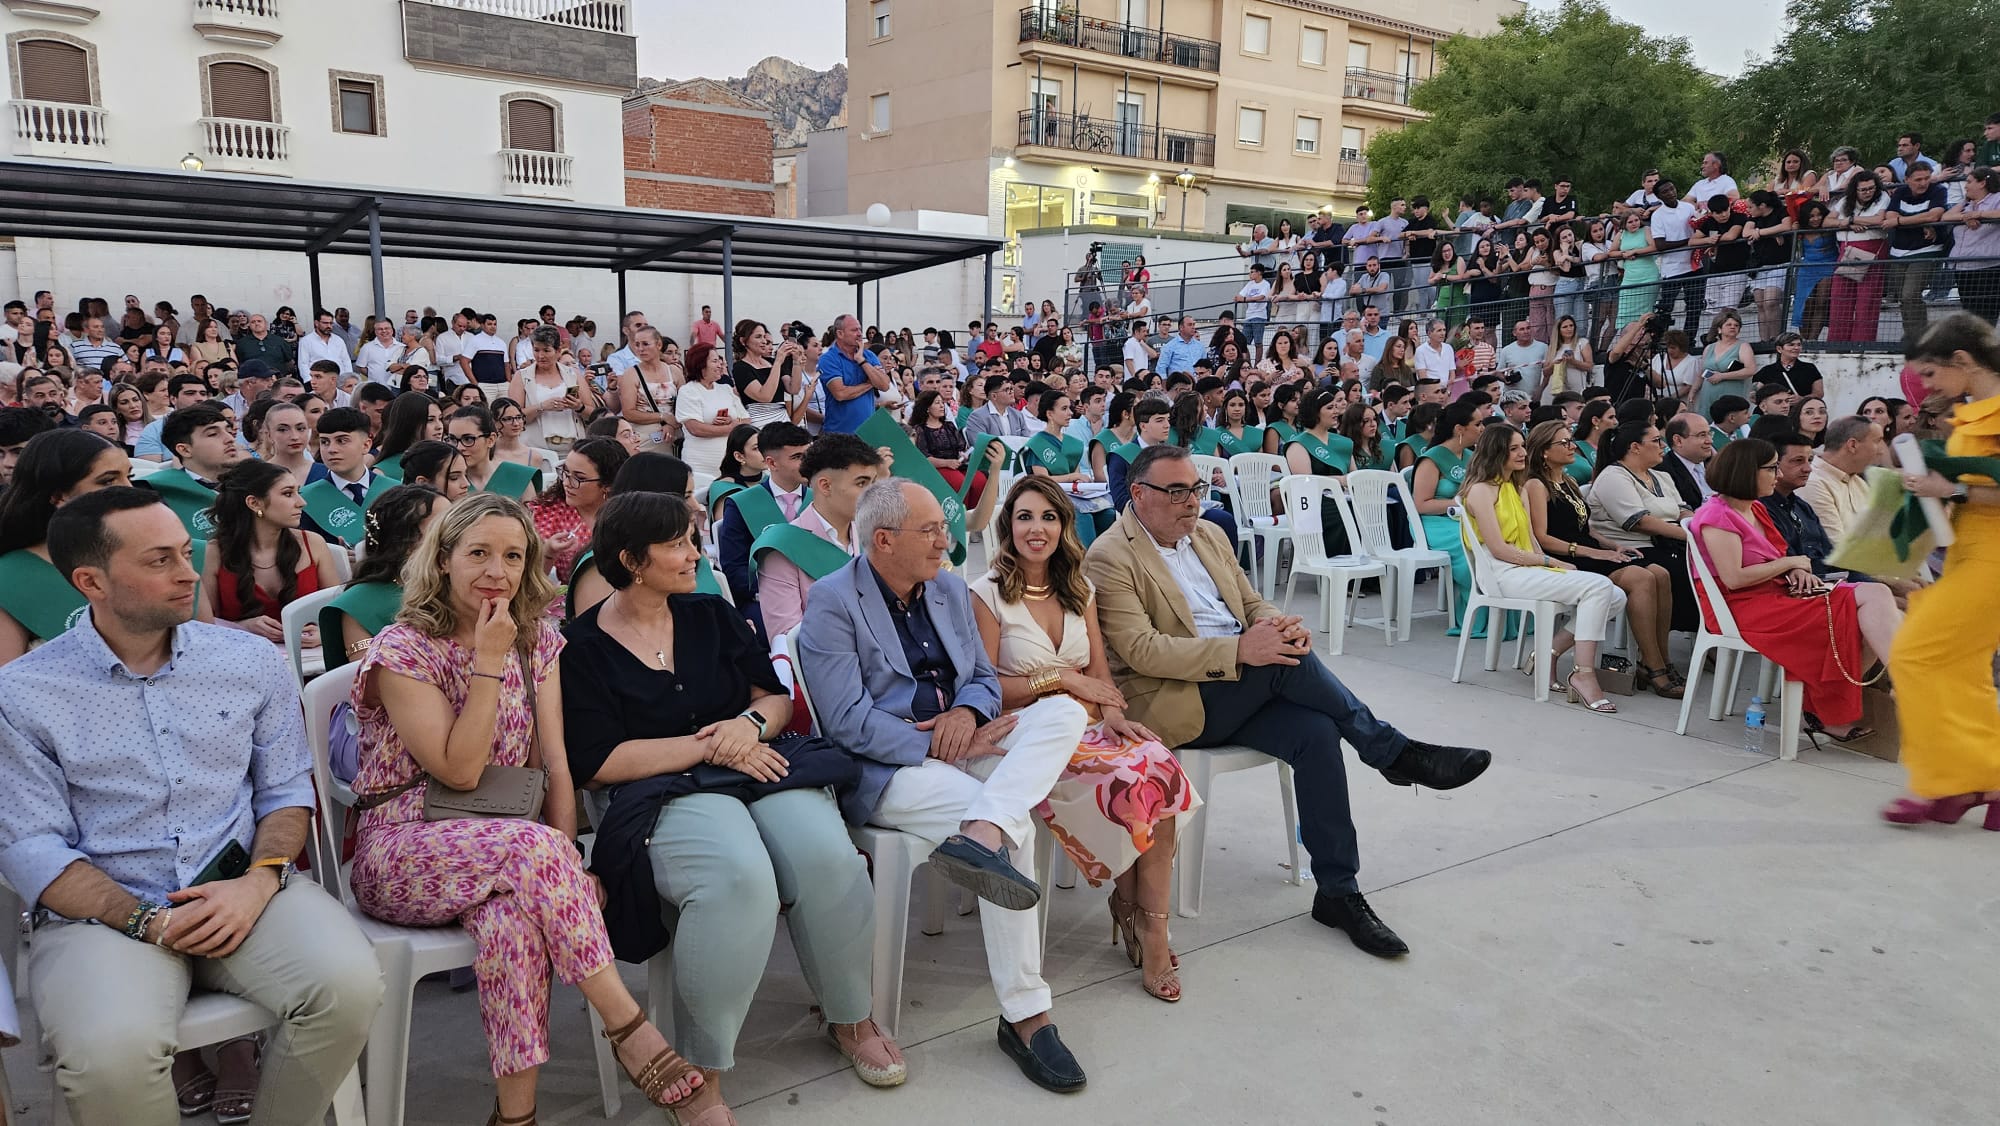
[354,492,712,1126]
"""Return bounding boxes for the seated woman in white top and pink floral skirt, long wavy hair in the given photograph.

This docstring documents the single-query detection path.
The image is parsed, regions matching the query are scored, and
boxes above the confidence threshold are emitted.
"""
[972,476,1202,1002]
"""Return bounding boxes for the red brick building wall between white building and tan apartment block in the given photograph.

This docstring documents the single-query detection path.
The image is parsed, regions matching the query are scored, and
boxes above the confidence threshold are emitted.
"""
[624,86,776,218]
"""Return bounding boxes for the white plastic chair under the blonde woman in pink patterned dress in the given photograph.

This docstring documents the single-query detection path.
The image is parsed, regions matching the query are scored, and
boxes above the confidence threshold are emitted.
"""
[304,660,622,1126]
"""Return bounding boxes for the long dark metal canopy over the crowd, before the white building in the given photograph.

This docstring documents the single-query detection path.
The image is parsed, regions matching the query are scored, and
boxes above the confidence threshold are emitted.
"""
[0,160,1000,348]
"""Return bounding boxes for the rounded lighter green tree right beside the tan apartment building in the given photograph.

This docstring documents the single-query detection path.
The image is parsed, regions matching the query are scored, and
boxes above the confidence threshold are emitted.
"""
[1368,0,1716,220]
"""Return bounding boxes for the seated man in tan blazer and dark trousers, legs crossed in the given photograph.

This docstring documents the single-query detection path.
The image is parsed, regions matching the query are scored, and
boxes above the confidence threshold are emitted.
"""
[1084,446,1492,958]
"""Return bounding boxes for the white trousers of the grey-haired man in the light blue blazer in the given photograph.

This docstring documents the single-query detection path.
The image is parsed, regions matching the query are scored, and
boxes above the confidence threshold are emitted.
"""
[870,696,1090,1020]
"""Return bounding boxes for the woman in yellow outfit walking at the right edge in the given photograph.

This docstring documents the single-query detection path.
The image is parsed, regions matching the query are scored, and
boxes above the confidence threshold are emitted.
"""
[1882,312,2000,830]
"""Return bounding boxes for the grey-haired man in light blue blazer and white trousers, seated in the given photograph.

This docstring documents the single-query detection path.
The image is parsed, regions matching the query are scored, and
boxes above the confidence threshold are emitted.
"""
[798,478,1090,1092]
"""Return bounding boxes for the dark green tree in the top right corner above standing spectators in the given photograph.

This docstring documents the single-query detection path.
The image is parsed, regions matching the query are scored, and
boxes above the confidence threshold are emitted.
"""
[1714,0,2000,174]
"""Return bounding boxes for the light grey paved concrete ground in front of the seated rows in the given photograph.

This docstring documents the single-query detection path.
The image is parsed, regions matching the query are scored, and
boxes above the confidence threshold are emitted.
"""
[6,594,2000,1126]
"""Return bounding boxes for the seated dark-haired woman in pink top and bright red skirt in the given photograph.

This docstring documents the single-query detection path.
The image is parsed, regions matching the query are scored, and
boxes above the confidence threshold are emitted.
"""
[1686,438,1902,742]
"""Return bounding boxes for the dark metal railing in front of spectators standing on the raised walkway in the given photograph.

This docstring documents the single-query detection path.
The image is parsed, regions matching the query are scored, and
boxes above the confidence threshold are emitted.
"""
[1064,216,2000,362]
